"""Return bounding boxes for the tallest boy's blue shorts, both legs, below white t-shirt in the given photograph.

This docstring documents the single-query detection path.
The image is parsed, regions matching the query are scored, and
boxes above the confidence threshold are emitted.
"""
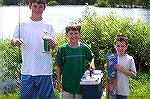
[20,75,55,99]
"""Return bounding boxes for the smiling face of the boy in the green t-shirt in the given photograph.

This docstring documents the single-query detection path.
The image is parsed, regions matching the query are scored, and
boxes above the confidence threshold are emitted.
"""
[67,30,80,43]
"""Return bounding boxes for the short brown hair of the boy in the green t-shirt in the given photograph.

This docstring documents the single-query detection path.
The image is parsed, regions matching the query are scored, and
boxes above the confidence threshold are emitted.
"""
[65,22,81,33]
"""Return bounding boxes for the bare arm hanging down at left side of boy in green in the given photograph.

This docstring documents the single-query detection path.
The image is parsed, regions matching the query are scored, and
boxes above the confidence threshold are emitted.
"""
[56,65,63,92]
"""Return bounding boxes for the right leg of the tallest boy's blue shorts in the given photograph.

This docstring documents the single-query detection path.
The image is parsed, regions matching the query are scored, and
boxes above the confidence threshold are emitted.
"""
[35,75,55,99]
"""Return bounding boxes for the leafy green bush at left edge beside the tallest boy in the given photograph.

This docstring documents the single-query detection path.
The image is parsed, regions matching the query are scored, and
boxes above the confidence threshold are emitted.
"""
[0,39,22,81]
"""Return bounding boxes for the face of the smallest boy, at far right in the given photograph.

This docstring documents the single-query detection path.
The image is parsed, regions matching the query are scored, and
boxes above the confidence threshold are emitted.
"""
[114,41,128,54]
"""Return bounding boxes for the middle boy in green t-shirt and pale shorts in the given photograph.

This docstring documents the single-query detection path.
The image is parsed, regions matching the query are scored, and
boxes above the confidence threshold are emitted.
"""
[55,23,95,99]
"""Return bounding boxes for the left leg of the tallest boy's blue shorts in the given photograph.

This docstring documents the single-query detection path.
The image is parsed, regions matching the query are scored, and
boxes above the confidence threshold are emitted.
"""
[20,75,36,99]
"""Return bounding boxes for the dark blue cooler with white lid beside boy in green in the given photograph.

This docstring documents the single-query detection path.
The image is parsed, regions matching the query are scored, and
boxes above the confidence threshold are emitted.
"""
[80,70,103,99]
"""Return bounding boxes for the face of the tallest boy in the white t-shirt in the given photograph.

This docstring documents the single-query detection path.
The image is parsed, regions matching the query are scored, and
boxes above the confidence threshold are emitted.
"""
[29,2,45,17]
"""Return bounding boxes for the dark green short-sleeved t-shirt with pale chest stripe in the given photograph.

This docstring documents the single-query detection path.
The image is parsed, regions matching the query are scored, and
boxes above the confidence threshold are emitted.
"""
[55,43,94,94]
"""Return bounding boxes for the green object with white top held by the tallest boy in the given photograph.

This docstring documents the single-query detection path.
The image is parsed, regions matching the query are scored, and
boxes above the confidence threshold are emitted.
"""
[43,31,53,53]
